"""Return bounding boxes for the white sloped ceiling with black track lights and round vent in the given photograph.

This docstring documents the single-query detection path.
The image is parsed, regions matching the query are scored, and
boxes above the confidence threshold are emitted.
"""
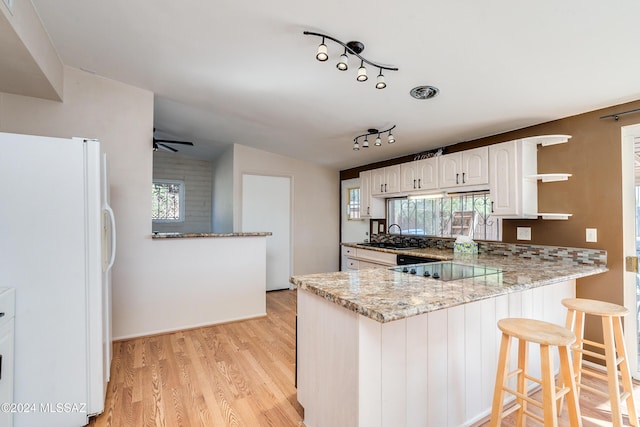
[32,0,640,169]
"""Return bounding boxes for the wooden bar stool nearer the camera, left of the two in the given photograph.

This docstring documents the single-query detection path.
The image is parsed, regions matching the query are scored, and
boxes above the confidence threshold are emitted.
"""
[490,319,582,427]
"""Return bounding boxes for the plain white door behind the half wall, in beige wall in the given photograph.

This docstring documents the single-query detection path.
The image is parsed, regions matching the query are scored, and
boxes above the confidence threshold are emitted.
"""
[242,174,291,291]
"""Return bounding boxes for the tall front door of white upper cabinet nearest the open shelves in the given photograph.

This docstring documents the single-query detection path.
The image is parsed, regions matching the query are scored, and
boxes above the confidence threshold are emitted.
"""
[489,141,519,215]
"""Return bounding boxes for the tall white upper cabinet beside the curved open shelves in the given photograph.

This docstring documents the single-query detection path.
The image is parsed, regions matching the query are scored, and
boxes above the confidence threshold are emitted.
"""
[489,140,538,218]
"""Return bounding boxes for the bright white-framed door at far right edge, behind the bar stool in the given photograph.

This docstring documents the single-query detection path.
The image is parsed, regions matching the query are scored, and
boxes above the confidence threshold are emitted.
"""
[622,124,640,379]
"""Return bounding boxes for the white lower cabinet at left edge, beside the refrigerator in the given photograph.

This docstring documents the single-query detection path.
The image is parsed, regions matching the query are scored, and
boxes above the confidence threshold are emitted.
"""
[0,288,15,427]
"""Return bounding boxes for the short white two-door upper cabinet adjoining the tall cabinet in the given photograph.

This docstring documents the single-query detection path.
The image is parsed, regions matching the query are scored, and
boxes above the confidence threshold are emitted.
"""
[438,147,489,189]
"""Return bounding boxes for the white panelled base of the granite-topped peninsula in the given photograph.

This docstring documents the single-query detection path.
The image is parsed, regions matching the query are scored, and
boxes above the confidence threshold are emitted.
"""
[296,280,575,427]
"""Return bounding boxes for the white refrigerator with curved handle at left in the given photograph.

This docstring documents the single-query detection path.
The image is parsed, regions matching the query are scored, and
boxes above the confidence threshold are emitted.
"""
[0,133,115,427]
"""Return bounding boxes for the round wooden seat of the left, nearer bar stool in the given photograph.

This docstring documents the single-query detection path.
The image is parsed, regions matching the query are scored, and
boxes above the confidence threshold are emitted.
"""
[498,318,576,346]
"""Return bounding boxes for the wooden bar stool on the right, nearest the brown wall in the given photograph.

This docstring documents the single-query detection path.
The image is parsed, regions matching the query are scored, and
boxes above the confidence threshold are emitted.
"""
[561,298,638,426]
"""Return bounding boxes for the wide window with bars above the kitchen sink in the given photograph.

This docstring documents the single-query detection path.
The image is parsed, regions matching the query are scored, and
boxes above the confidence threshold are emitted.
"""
[387,192,501,240]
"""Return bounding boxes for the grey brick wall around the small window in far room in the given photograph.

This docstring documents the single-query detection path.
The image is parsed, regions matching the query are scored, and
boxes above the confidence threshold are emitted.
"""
[153,151,213,233]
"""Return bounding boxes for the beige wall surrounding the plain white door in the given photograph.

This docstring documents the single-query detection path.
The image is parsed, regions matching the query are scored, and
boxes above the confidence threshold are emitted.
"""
[234,145,340,274]
